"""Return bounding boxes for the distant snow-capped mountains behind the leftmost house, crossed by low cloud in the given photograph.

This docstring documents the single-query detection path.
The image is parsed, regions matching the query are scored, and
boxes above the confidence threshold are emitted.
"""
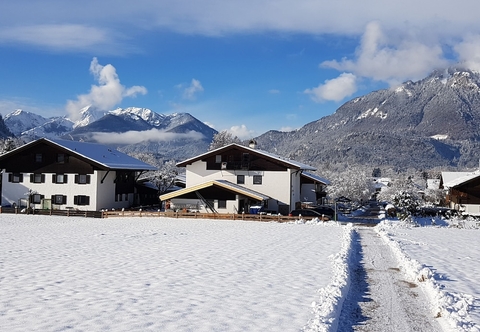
[0,107,217,160]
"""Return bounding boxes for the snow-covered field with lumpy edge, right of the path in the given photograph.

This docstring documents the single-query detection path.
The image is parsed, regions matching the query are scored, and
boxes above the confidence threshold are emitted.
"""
[376,219,480,331]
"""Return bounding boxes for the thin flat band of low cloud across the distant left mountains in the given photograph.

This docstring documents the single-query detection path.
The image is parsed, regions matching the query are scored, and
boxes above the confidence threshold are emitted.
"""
[92,129,204,144]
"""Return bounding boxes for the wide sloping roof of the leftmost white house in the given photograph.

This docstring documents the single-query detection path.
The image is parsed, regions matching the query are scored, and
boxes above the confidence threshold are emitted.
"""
[2,138,157,171]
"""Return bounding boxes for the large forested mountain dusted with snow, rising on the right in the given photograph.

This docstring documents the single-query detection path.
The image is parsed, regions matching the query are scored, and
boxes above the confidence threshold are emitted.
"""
[257,68,480,171]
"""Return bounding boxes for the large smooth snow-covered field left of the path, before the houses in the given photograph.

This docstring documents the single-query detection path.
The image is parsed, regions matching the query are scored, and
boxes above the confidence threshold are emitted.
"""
[0,214,352,331]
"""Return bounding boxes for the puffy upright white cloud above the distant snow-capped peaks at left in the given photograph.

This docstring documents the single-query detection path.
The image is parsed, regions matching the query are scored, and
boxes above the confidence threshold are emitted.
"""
[66,58,147,120]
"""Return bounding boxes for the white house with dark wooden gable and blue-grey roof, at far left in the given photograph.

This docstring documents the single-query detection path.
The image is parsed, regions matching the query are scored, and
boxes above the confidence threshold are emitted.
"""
[0,138,156,210]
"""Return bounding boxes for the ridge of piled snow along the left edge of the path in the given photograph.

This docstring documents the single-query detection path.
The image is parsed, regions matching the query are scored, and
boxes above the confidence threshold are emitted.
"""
[303,224,354,332]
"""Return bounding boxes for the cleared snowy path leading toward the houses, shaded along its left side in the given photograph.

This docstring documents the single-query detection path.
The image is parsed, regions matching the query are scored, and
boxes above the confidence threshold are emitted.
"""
[338,227,442,332]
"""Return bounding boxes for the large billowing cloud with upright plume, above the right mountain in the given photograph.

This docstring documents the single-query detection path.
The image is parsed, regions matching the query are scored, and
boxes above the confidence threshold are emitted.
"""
[321,22,448,85]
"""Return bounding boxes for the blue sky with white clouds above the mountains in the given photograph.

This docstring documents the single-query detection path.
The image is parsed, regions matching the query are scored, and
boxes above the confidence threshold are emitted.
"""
[0,0,480,139]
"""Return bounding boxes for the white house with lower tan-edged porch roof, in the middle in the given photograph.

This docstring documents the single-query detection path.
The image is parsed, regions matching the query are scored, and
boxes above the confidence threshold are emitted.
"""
[160,143,329,215]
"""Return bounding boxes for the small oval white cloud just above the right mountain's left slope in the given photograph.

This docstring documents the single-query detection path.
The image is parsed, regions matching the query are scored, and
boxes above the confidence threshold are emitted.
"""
[304,73,357,103]
